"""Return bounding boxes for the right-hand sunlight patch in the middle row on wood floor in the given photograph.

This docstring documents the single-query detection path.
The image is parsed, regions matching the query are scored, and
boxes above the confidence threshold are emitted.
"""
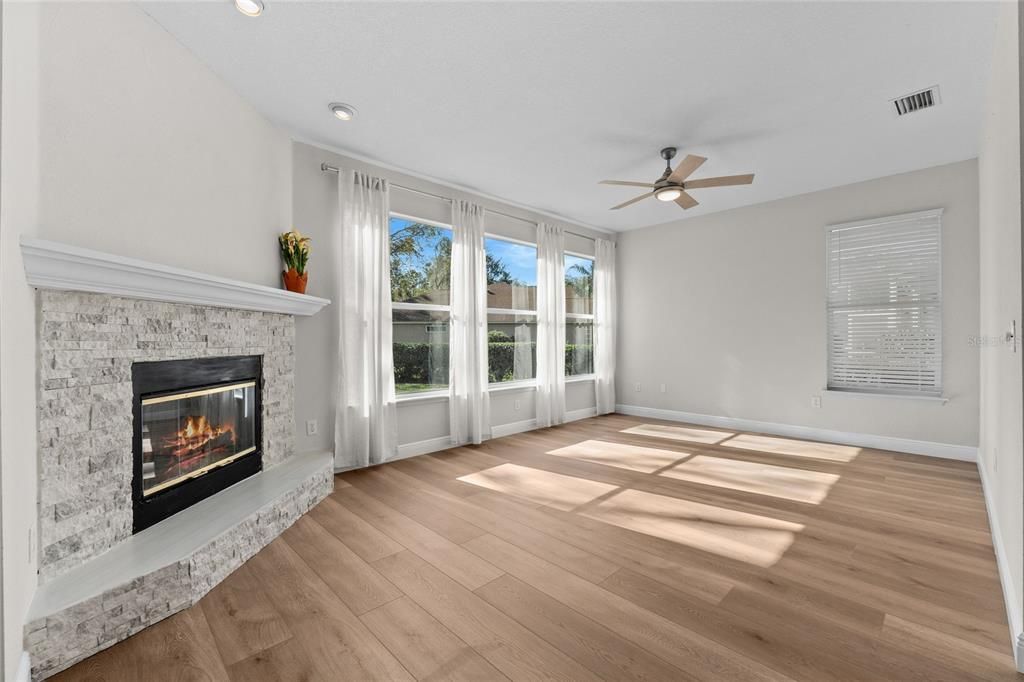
[658,455,839,504]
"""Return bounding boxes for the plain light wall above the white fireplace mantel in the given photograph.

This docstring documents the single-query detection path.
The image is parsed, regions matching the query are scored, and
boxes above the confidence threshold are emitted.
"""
[33,2,292,287]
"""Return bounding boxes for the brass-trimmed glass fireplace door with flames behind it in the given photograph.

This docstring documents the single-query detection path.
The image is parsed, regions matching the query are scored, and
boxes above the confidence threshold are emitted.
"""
[141,381,257,498]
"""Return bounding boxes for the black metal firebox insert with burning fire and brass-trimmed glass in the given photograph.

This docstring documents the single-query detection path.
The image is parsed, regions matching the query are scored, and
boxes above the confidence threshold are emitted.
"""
[132,355,262,532]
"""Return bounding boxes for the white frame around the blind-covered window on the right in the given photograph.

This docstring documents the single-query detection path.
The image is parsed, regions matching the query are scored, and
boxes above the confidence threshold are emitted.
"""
[823,208,948,403]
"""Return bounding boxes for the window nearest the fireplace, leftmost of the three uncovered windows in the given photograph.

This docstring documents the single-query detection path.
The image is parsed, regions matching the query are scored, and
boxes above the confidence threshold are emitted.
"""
[390,215,452,394]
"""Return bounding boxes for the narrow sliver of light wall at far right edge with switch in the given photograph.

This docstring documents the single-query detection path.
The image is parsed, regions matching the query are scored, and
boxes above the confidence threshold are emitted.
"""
[978,3,1024,665]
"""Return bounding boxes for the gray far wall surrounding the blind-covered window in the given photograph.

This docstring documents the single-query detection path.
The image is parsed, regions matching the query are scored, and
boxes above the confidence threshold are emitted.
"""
[617,161,978,445]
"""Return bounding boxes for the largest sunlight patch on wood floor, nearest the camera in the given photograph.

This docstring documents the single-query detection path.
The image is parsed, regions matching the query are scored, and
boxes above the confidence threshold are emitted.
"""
[580,488,804,566]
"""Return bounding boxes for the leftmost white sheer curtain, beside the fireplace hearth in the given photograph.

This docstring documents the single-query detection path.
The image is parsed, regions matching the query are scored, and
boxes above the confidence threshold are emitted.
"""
[334,169,398,469]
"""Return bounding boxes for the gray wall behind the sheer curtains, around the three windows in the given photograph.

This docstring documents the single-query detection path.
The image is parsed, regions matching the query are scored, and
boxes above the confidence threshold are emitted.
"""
[292,142,609,452]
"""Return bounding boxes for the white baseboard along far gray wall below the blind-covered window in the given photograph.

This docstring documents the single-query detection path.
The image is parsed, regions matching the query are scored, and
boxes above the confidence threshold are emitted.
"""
[615,404,978,462]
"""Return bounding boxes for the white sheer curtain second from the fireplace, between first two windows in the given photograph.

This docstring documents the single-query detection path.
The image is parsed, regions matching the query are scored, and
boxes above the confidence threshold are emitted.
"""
[449,201,490,445]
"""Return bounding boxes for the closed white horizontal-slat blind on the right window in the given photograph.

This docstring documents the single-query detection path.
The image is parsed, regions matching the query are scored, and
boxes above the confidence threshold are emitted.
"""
[825,209,942,395]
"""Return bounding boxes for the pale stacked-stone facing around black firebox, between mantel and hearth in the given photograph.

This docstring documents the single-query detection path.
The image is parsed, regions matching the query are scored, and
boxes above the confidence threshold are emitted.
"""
[38,291,295,582]
